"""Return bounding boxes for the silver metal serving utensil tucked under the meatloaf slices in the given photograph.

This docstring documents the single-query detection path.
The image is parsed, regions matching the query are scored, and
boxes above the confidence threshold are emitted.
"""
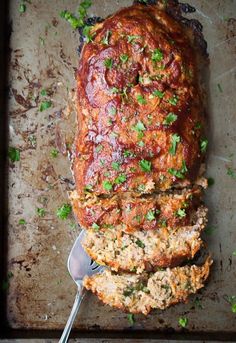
[59,230,103,343]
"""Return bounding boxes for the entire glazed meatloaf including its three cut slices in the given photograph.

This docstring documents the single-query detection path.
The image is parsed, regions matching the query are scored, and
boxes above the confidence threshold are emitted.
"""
[70,1,211,313]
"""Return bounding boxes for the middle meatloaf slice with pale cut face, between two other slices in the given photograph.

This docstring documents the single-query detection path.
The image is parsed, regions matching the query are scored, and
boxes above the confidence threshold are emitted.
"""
[82,207,207,273]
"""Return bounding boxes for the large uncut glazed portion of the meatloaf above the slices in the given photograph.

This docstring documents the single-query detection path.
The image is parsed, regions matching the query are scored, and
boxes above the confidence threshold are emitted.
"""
[73,4,206,196]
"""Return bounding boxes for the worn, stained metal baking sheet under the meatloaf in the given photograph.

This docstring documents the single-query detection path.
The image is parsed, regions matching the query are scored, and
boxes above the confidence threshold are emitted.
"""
[2,0,236,339]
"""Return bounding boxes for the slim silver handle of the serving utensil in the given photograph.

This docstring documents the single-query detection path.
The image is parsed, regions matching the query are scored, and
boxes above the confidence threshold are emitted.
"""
[59,285,85,343]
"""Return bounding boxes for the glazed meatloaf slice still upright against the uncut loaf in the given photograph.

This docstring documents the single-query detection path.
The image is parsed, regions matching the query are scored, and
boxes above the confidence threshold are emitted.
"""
[70,187,202,232]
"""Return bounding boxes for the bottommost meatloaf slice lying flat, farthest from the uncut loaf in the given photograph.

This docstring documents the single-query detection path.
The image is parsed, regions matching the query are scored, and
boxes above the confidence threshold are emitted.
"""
[84,258,212,315]
